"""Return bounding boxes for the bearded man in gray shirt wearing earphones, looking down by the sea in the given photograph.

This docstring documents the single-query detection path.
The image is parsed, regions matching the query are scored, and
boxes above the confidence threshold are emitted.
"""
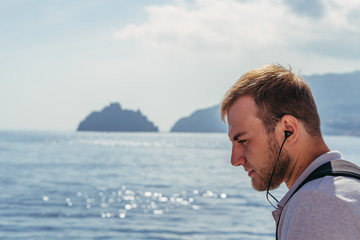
[221,65,360,240]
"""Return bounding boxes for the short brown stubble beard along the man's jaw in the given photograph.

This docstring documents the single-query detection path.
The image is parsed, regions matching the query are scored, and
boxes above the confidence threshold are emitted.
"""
[252,134,291,191]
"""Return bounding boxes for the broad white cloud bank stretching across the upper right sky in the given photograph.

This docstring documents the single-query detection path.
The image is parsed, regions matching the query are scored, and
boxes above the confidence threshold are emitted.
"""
[114,0,360,59]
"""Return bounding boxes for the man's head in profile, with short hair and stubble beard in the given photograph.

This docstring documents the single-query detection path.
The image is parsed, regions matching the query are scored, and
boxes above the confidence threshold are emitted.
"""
[221,65,321,191]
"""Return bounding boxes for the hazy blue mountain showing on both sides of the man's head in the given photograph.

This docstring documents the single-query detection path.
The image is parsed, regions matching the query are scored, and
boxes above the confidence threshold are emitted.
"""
[171,71,360,135]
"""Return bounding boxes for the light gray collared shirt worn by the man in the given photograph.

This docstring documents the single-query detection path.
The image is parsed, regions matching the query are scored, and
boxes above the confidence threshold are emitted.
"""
[273,151,360,240]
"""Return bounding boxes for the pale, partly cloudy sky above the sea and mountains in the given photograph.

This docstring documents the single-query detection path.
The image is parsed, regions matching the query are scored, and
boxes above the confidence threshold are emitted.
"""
[0,0,360,132]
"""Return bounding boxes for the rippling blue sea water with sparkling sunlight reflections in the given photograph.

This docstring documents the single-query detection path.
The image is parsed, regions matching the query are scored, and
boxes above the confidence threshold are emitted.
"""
[0,131,360,240]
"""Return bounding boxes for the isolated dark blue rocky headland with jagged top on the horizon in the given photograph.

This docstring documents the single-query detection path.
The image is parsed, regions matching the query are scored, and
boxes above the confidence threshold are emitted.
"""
[77,103,159,132]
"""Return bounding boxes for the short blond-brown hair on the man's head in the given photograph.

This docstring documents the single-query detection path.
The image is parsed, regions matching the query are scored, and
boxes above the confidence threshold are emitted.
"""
[221,64,321,136]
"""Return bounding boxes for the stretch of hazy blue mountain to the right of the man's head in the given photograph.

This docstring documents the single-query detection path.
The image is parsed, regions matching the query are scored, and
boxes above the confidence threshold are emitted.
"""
[304,71,360,135]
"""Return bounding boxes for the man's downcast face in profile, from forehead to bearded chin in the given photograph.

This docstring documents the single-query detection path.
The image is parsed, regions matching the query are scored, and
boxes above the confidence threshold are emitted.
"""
[227,96,290,191]
